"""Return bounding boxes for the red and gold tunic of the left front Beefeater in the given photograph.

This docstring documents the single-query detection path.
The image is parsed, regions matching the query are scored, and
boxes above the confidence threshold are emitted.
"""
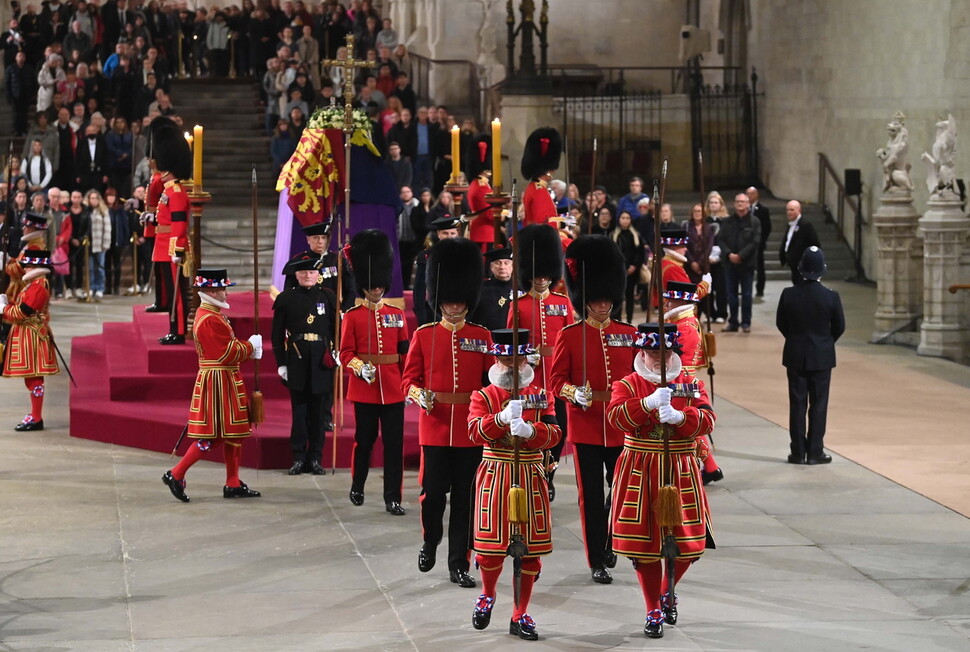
[468,385,562,557]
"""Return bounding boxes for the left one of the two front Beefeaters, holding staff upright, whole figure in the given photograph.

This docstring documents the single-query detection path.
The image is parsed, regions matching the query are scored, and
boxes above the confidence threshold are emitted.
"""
[468,328,562,641]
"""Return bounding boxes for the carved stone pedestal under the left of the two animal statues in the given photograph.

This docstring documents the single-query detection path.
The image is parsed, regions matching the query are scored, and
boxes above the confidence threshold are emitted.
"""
[872,192,923,341]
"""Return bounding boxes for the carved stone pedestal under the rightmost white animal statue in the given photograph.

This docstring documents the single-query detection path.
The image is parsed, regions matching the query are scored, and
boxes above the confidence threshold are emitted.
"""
[916,195,970,360]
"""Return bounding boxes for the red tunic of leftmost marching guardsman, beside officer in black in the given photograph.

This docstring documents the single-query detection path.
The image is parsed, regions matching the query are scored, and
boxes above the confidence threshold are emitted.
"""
[340,302,408,405]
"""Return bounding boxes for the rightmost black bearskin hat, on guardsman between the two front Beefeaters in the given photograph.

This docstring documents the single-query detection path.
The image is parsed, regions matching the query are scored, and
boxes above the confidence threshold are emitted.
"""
[566,235,626,315]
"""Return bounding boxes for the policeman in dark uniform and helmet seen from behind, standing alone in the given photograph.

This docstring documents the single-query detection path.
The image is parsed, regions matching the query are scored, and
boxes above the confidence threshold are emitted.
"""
[775,246,845,464]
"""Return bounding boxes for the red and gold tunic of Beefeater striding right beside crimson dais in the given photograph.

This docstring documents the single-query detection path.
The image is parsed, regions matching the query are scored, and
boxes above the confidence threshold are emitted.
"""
[188,303,253,439]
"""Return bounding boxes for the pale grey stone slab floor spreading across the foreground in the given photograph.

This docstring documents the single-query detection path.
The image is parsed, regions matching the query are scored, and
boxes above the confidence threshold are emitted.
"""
[0,283,970,651]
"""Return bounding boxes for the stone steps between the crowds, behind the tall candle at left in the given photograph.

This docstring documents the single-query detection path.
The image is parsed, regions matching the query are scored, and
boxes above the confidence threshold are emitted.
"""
[172,79,278,287]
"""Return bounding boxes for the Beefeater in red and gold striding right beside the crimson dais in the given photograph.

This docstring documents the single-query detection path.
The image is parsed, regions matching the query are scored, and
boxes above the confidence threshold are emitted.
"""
[162,269,263,503]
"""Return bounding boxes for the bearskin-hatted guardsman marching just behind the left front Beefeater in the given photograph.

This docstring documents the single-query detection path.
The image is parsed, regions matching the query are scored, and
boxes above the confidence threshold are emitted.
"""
[402,238,494,588]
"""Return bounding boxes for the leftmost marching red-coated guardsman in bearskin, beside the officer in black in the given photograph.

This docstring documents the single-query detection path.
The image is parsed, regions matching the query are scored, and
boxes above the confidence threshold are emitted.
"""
[340,229,409,516]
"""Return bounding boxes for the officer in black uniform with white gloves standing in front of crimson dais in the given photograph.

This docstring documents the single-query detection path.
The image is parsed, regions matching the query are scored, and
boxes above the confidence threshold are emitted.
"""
[273,253,337,475]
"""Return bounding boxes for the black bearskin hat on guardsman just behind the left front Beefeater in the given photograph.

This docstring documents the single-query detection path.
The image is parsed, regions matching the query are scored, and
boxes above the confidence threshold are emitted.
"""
[427,238,485,312]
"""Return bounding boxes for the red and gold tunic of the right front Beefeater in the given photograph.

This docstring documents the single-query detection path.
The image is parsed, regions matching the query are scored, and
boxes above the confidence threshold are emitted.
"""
[607,372,714,560]
